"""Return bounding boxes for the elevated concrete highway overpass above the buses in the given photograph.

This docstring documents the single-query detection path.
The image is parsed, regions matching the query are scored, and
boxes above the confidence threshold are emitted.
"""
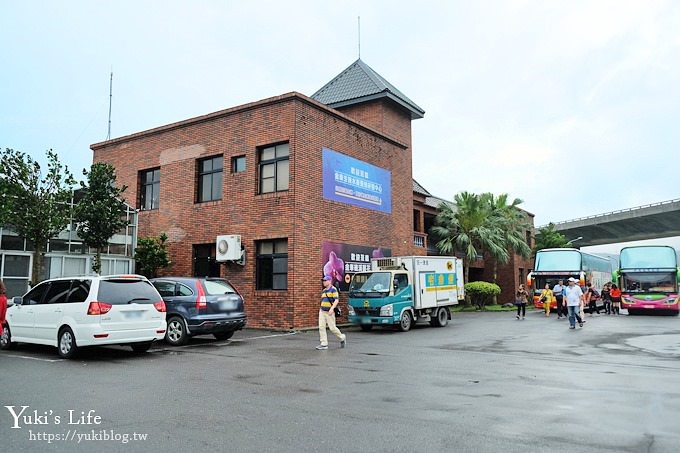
[540,198,680,247]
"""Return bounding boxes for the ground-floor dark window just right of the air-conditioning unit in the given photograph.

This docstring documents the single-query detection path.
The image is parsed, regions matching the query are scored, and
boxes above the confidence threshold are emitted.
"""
[256,239,288,290]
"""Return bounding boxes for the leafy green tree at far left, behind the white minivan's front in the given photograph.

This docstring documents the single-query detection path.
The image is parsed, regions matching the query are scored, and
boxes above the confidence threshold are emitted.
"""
[0,148,75,283]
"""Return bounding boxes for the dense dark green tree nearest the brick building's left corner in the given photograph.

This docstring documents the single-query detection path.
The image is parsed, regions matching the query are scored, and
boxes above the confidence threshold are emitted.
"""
[74,163,127,274]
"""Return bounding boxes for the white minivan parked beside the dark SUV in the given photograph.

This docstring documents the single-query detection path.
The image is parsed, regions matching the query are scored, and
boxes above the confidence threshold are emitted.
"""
[0,275,167,358]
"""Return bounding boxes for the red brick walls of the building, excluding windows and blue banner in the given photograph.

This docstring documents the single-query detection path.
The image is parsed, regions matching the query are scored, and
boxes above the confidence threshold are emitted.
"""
[92,93,413,329]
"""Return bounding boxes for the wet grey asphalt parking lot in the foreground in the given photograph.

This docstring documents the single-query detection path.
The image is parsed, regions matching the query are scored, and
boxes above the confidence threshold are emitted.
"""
[0,312,680,452]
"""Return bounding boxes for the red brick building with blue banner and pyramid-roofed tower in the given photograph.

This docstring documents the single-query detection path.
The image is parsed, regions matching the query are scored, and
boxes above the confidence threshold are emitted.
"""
[91,60,536,329]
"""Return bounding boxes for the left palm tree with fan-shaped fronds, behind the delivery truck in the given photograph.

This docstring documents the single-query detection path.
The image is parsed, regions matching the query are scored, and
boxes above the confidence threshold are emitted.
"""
[431,192,508,304]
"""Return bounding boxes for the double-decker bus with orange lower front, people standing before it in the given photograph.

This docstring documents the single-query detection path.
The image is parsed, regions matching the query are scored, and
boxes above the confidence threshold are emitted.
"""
[527,248,612,309]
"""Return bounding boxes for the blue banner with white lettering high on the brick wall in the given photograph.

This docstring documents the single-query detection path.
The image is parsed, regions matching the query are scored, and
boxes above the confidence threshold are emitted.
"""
[323,148,392,213]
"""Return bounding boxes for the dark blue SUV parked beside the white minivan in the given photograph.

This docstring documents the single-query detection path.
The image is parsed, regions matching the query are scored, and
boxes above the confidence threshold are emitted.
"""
[151,277,247,346]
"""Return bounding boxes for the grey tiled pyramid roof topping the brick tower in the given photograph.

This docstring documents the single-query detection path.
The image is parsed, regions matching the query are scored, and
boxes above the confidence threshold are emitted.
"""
[312,59,425,119]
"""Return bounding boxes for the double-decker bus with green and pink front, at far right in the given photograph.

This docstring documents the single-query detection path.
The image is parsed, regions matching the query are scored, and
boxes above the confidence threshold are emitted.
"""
[614,245,680,315]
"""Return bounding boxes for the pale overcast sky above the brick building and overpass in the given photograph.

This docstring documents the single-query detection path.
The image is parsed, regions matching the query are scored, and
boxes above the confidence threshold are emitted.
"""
[0,0,680,251]
